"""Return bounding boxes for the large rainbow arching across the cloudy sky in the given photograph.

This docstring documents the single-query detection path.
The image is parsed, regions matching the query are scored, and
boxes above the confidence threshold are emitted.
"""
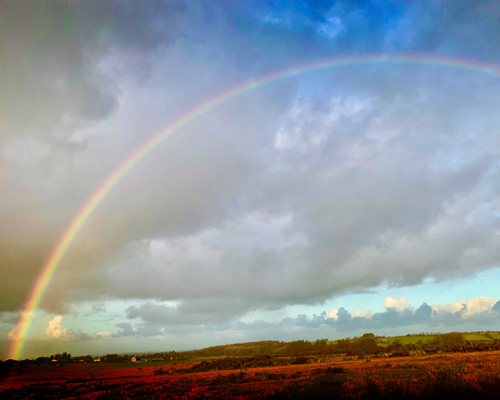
[7,54,500,359]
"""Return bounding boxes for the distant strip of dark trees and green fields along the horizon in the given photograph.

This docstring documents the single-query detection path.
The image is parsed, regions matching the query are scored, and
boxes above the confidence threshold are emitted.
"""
[0,332,500,368]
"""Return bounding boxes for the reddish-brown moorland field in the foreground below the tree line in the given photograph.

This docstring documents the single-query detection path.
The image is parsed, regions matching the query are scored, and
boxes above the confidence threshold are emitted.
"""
[0,351,500,399]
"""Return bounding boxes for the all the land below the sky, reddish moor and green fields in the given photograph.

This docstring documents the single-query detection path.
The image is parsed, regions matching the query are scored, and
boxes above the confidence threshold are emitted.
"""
[0,332,500,400]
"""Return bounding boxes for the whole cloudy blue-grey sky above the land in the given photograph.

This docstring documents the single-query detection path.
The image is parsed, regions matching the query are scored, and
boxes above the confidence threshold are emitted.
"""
[0,0,500,359]
